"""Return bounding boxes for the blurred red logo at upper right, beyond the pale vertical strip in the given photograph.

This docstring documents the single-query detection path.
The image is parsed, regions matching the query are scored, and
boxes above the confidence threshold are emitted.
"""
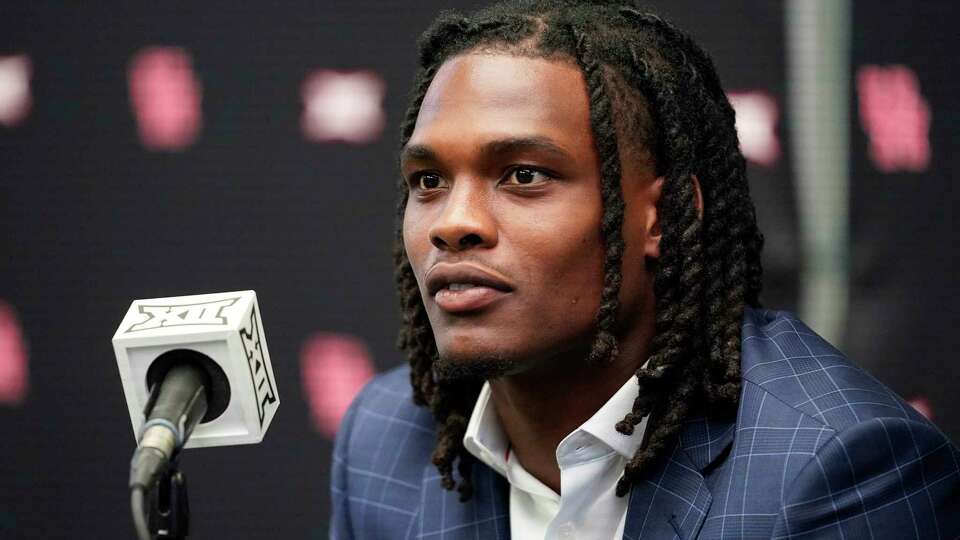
[857,65,930,172]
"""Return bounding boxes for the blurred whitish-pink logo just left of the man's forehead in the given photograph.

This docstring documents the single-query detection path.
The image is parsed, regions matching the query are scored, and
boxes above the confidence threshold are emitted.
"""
[300,69,386,143]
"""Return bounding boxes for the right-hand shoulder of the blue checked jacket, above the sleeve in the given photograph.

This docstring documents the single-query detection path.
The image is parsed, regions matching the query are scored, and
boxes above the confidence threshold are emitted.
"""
[741,310,932,431]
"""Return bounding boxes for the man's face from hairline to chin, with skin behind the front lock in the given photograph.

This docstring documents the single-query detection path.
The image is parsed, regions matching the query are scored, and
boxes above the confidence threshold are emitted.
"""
[401,54,659,375]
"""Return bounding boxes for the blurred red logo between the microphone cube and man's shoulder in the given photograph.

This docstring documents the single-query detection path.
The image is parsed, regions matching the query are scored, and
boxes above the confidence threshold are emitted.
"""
[300,333,374,438]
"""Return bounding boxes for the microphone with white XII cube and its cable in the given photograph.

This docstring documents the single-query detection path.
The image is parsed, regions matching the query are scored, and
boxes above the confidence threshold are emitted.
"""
[113,291,280,536]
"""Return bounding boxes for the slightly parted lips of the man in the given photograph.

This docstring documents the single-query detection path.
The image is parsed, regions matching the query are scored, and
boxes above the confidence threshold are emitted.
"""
[426,263,513,313]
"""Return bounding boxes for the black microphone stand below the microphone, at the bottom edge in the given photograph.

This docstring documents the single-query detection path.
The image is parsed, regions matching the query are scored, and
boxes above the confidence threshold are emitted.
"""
[147,455,190,540]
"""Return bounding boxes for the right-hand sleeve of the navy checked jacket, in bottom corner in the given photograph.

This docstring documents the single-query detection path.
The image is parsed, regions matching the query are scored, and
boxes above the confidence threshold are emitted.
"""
[773,418,960,539]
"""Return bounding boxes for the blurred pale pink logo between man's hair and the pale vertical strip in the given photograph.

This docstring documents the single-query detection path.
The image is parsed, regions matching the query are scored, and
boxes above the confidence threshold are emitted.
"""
[727,90,780,167]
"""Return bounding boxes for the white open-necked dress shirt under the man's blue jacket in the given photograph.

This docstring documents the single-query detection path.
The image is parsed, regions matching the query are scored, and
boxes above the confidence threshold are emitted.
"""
[463,377,647,540]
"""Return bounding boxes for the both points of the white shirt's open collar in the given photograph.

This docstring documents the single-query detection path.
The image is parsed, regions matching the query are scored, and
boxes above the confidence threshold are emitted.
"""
[463,376,647,476]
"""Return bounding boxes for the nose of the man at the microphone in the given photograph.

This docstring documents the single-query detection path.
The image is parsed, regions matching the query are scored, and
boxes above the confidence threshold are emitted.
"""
[430,179,497,251]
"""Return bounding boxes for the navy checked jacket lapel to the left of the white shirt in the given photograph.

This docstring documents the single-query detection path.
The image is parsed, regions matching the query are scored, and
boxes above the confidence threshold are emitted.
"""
[413,461,510,540]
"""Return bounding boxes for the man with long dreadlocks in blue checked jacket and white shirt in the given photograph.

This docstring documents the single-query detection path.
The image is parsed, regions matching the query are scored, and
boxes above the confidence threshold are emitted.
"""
[331,2,960,539]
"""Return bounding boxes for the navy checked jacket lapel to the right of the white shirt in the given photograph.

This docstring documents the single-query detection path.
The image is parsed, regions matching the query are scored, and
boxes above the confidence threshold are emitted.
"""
[623,418,735,540]
